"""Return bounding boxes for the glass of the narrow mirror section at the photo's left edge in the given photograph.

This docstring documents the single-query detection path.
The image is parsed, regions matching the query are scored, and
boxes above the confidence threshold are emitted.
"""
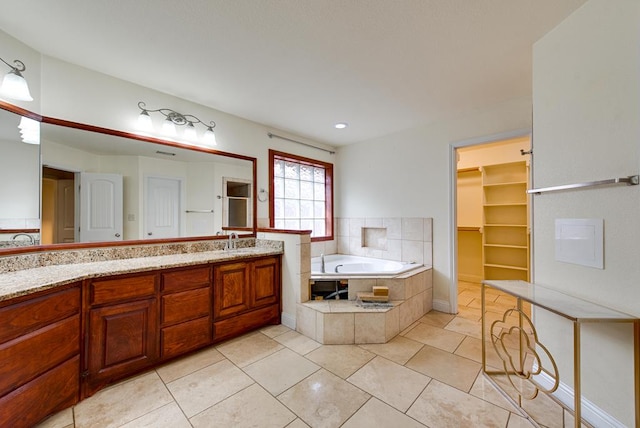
[0,110,40,248]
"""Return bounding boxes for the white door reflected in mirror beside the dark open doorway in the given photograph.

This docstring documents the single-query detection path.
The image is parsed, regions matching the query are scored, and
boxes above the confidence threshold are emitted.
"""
[79,172,122,242]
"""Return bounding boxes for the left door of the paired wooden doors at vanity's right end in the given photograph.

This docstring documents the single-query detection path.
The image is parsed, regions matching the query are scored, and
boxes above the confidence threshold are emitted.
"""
[213,262,250,319]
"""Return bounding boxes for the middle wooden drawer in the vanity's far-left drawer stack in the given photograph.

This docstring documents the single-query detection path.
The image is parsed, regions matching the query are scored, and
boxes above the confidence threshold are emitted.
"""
[0,315,80,395]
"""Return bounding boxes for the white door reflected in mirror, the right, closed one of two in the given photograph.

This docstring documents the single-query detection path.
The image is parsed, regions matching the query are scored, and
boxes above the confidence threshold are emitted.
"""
[145,177,182,239]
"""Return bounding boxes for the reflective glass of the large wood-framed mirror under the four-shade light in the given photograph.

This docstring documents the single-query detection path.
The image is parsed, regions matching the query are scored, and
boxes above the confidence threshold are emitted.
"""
[41,124,254,244]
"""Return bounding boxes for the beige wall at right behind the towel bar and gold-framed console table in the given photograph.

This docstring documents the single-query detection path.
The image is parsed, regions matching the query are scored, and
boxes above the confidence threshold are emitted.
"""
[533,0,640,426]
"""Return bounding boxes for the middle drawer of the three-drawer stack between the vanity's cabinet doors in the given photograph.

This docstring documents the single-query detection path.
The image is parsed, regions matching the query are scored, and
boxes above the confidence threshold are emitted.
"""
[161,287,211,325]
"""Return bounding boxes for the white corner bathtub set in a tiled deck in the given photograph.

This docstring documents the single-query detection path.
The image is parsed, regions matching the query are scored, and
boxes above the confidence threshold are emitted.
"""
[311,254,422,279]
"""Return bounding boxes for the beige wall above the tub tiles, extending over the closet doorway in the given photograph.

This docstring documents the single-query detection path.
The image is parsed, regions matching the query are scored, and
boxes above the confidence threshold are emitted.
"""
[336,97,531,312]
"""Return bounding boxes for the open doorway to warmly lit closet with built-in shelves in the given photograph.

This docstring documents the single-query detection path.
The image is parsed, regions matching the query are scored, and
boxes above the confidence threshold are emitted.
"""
[452,135,531,309]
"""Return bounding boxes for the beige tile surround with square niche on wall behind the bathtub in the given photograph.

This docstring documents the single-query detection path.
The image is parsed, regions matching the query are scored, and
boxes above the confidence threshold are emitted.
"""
[311,217,433,265]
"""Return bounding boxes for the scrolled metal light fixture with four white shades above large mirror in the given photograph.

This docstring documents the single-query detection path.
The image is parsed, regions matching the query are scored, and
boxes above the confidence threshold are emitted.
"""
[138,101,217,146]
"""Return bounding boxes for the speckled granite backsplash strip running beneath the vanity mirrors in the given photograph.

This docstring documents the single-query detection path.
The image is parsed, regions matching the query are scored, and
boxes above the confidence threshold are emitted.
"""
[0,238,282,273]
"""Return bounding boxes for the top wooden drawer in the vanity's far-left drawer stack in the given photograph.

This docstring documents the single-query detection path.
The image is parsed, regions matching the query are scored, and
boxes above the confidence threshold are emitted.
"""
[0,287,80,343]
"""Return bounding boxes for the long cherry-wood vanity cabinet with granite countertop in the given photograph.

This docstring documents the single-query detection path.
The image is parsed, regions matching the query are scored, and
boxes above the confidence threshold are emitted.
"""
[0,248,282,427]
